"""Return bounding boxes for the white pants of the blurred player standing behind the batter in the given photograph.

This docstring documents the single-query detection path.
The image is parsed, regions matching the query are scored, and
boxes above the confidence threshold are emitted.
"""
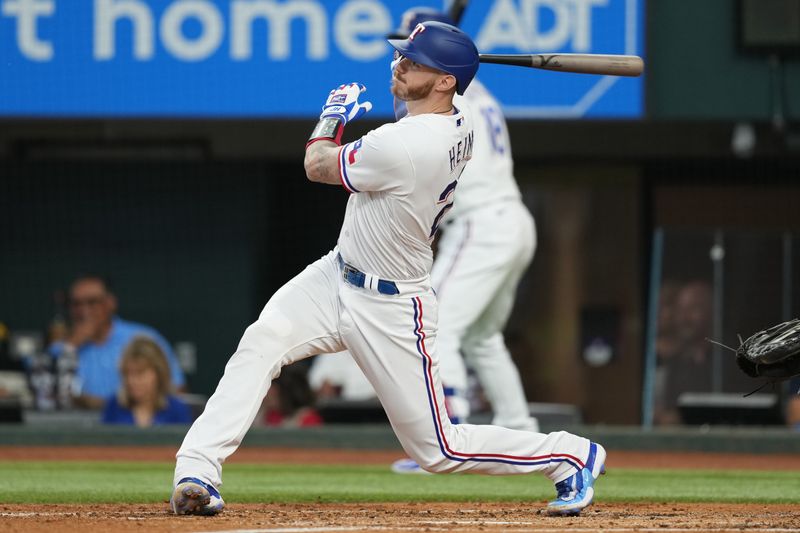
[431,200,536,429]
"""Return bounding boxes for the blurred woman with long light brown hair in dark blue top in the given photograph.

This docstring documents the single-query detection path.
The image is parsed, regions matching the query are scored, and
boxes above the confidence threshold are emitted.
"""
[102,337,192,427]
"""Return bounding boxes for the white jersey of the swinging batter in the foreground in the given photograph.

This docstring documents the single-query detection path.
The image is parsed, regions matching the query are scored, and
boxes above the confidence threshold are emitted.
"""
[339,111,473,281]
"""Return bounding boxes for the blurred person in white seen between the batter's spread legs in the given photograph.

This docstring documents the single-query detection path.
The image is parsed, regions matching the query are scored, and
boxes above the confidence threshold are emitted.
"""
[308,352,376,401]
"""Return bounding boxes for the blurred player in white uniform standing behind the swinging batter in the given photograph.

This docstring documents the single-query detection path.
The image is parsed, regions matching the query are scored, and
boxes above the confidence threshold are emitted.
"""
[390,7,539,473]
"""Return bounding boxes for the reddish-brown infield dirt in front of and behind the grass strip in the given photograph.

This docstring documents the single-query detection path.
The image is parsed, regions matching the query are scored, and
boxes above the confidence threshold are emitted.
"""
[0,447,800,533]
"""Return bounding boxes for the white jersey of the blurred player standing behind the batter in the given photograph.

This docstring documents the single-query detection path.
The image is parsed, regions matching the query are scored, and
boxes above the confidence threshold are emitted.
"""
[445,80,521,220]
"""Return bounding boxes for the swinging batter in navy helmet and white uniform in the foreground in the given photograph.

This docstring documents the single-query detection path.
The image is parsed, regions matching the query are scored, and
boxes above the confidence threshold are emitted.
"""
[170,22,606,515]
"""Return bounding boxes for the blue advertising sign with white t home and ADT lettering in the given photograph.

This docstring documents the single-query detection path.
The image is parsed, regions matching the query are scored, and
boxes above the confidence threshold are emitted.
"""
[0,0,643,118]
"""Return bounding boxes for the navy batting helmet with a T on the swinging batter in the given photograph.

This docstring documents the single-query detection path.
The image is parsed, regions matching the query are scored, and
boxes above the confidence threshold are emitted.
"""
[388,21,480,94]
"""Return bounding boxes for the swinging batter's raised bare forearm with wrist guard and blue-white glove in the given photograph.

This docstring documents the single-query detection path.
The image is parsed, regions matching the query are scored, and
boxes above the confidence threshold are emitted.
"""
[304,83,372,185]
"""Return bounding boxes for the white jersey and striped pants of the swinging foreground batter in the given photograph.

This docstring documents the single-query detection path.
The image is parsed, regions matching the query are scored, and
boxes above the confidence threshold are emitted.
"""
[175,94,591,494]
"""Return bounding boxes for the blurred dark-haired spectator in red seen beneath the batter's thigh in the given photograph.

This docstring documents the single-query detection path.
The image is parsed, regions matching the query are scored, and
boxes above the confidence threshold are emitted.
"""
[263,364,322,427]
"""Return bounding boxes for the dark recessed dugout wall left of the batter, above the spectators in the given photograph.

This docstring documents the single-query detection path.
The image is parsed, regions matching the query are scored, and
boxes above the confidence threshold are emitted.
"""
[0,159,346,393]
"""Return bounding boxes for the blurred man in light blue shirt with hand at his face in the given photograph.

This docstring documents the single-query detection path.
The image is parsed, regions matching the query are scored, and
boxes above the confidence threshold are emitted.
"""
[48,275,185,409]
